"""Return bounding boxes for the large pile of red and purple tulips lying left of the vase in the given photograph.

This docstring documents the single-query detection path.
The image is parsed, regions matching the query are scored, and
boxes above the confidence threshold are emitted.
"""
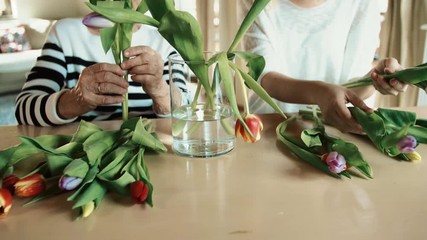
[0,118,166,218]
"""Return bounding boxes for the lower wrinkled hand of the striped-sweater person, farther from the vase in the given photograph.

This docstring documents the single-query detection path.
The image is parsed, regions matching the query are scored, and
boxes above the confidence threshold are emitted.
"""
[72,63,129,111]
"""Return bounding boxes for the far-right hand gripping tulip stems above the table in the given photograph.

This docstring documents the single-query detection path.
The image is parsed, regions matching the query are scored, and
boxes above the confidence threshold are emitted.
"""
[371,58,408,96]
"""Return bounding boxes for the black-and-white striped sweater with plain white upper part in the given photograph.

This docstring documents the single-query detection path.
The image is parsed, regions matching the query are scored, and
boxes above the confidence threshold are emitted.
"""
[15,19,187,126]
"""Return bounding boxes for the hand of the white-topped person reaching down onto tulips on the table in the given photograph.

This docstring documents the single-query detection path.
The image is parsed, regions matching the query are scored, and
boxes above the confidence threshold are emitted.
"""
[317,83,373,134]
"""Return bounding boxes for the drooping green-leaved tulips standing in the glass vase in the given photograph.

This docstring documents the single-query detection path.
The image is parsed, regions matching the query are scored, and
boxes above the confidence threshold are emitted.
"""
[87,0,286,142]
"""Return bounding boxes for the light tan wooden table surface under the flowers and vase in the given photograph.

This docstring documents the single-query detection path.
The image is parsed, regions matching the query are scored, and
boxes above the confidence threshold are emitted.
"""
[0,107,427,240]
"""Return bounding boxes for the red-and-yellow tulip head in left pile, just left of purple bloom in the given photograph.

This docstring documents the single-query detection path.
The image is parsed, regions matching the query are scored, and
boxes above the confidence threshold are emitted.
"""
[15,174,46,197]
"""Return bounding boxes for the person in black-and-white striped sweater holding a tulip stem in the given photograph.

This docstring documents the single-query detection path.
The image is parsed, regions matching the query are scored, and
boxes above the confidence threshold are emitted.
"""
[15,0,186,126]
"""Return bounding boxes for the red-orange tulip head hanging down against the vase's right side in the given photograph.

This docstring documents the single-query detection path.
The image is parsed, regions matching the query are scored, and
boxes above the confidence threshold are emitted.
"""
[234,114,264,143]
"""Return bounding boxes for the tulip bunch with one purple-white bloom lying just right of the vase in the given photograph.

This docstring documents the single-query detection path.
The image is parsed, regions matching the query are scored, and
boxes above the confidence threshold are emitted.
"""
[276,112,372,178]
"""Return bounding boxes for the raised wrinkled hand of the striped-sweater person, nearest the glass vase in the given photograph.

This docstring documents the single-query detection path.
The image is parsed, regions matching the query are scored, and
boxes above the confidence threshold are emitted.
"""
[121,46,169,101]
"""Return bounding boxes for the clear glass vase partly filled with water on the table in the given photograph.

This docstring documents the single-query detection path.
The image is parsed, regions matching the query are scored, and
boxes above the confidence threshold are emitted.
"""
[169,55,236,158]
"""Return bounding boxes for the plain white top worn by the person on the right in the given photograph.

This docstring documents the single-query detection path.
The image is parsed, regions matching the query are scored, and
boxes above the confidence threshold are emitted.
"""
[244,0,381,113]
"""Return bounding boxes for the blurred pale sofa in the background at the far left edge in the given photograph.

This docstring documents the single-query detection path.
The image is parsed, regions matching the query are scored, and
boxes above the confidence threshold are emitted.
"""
[0,18,55,95]
